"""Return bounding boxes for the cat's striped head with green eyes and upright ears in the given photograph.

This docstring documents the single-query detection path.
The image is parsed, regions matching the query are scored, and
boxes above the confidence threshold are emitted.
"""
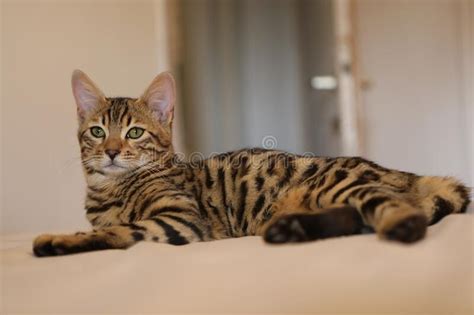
[72,70,176,176]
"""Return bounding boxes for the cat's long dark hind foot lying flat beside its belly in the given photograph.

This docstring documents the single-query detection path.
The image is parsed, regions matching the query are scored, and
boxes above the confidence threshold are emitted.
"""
[263,206,364,243]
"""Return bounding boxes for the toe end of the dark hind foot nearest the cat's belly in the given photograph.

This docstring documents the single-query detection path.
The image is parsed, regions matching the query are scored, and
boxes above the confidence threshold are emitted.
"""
[263,215,308,244]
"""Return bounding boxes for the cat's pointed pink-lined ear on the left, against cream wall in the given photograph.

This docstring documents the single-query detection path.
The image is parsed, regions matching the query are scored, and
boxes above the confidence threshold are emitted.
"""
[71,70,105,121]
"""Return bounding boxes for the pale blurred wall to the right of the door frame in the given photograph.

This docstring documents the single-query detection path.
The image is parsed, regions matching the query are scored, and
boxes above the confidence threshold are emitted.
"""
[356,0,473,185]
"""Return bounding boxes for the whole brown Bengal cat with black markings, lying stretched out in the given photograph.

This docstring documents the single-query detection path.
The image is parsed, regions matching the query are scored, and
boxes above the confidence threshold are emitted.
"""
[33,70,470,256]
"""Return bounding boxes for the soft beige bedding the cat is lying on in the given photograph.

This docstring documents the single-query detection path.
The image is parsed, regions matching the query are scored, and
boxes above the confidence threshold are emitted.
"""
[0,214,474,314]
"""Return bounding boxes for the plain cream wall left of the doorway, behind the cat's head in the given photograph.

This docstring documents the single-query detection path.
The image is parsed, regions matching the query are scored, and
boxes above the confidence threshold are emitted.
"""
[1,0,166,232]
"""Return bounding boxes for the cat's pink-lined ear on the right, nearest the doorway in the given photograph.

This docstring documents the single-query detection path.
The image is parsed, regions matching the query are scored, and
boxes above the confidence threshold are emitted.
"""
[141,72,176,124]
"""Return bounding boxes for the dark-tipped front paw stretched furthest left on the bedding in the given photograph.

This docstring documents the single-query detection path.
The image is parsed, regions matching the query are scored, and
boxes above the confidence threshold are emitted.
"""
[33,233,110,257]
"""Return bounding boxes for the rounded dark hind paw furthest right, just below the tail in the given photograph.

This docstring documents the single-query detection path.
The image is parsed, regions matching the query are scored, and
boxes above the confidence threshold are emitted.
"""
[382,214,428,243]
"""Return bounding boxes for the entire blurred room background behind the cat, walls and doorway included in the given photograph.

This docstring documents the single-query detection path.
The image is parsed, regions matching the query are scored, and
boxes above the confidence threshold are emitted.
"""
[0,0,474,232]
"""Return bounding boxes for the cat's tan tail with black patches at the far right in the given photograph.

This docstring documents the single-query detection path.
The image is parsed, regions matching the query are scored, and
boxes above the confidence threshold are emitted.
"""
[413,176,471,224]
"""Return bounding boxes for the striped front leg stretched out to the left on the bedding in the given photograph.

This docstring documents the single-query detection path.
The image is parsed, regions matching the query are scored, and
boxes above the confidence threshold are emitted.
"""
[33,213,208,256]
